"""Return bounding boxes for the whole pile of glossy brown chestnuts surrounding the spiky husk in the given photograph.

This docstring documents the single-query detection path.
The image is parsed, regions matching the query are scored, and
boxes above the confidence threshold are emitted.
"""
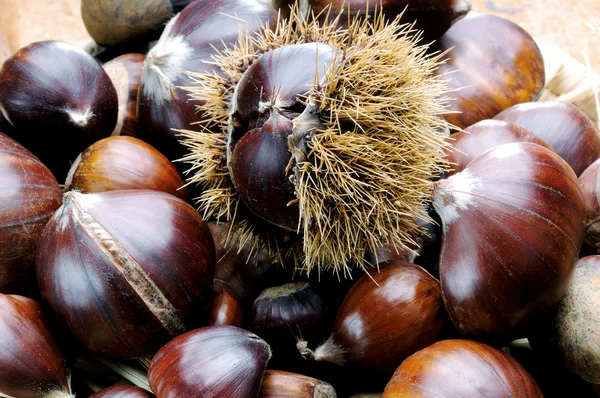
[0,0,600,398]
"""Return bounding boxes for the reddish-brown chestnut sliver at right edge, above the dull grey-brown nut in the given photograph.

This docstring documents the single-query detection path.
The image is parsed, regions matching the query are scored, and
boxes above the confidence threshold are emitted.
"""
[579,159,600,250]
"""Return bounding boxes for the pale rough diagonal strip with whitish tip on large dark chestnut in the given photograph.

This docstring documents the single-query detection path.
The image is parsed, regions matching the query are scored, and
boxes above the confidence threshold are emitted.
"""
[59,192,186,337]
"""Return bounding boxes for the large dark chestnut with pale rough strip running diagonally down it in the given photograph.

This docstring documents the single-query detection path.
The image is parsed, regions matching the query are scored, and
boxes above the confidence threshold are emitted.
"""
[35,190,215,359]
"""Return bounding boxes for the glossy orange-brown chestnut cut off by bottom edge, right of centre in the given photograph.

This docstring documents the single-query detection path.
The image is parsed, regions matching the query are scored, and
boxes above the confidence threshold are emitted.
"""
[383,340,543,398]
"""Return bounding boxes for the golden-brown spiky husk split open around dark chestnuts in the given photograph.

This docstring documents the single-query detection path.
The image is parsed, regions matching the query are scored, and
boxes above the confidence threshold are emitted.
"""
[182,3,449,275]
